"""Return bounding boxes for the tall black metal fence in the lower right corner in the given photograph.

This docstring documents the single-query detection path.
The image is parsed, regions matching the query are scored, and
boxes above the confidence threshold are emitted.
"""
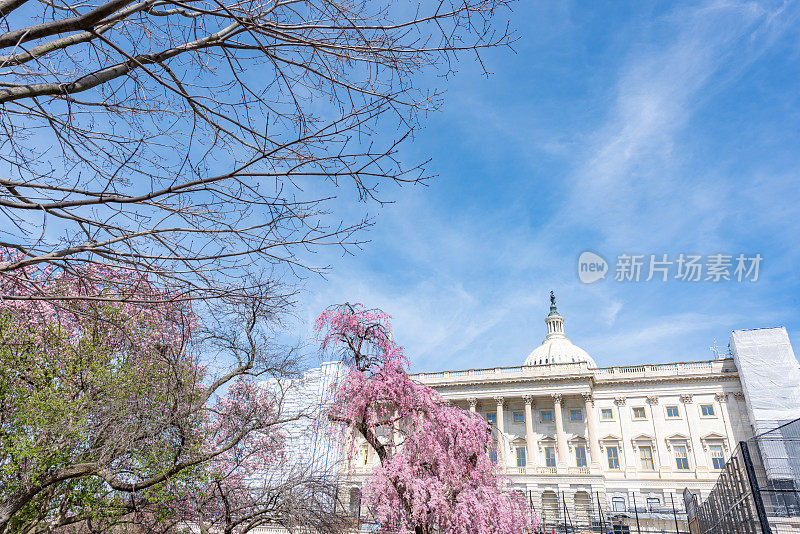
[687,419,800,534]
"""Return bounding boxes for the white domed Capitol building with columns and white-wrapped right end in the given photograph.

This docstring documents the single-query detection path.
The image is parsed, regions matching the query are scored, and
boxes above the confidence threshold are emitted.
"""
[340,293,800,532]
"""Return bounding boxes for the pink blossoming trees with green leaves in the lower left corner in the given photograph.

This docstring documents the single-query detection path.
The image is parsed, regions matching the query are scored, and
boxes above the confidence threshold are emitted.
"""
[0,252,346,534]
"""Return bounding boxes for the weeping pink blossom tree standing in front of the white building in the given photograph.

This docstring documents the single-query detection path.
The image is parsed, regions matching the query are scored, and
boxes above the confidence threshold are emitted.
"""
[315,304,537,534]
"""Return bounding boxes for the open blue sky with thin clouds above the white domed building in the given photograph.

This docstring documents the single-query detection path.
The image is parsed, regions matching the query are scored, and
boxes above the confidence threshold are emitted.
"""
[292,1,800,371]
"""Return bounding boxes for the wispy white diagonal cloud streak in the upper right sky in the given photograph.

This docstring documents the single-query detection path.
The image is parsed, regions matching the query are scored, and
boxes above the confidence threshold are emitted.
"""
[564,1,796,247]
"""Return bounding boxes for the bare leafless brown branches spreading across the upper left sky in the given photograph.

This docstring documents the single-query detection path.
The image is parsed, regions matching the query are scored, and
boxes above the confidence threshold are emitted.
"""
[0,0,511,299]
